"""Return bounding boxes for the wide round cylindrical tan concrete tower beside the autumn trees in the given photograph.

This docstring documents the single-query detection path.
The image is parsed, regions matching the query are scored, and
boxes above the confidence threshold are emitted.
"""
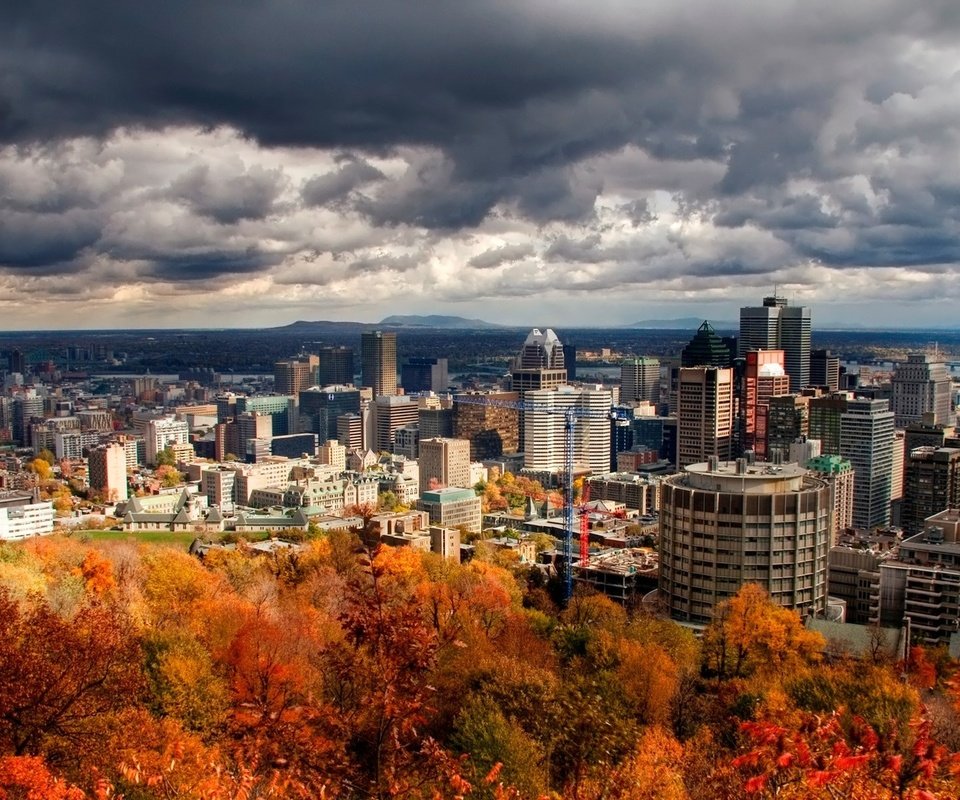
[660,459,833,623]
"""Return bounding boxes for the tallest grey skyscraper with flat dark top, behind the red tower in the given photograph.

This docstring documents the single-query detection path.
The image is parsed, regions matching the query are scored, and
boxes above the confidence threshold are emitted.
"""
[739,297,811,393]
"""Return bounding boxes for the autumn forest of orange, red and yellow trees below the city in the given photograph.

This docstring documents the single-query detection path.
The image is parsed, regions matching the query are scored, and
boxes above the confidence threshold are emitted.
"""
[0,533,960,800]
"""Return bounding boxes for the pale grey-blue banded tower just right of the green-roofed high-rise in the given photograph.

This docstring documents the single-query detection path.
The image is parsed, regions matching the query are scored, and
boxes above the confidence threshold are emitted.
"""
[840,398,894,528]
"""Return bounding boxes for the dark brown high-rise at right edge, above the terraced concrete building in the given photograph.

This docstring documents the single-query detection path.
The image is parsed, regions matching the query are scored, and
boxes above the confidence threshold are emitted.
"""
[900,447,960,536]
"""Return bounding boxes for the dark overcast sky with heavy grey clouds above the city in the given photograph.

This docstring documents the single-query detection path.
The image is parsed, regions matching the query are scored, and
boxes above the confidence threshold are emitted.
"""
[0,0,960,329]
